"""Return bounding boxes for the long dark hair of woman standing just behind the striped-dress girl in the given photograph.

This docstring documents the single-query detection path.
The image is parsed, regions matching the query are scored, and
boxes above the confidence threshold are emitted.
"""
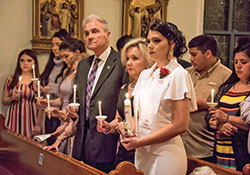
[40,29,70,85]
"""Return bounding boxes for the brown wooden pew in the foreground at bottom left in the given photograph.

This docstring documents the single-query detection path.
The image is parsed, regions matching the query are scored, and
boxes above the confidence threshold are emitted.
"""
[0,115,143,175]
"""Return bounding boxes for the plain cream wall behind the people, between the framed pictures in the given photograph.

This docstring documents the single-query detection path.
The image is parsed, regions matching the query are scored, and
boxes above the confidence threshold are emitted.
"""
[0,0,204,114]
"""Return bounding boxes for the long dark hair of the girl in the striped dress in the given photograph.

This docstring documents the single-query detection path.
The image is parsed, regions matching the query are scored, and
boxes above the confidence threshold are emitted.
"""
[8,49,39,90]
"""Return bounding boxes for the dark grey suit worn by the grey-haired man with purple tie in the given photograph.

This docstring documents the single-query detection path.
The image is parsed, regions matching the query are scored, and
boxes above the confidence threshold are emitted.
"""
[73,49,124,166]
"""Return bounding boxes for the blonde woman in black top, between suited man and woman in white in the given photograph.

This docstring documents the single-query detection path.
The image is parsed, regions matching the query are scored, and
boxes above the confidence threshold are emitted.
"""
[97,38,153,165]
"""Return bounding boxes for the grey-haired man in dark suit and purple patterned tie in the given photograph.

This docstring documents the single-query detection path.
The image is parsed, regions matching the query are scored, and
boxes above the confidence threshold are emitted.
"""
[72,15,124,173]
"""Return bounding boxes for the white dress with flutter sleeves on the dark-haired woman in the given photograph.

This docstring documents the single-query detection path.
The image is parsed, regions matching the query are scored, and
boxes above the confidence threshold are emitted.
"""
[134,59,197,175]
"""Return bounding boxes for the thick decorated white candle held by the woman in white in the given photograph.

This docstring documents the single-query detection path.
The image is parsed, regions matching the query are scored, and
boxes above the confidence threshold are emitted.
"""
[124,93,132,134]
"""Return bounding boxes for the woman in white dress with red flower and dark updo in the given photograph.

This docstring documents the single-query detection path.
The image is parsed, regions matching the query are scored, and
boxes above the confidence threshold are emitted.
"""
[121,22,197,175]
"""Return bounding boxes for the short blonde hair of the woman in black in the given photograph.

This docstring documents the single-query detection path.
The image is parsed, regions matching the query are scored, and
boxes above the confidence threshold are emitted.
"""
[121,38,154,68]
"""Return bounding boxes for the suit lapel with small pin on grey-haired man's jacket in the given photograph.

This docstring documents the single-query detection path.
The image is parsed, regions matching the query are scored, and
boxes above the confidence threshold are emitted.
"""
[92,50,117,97]
